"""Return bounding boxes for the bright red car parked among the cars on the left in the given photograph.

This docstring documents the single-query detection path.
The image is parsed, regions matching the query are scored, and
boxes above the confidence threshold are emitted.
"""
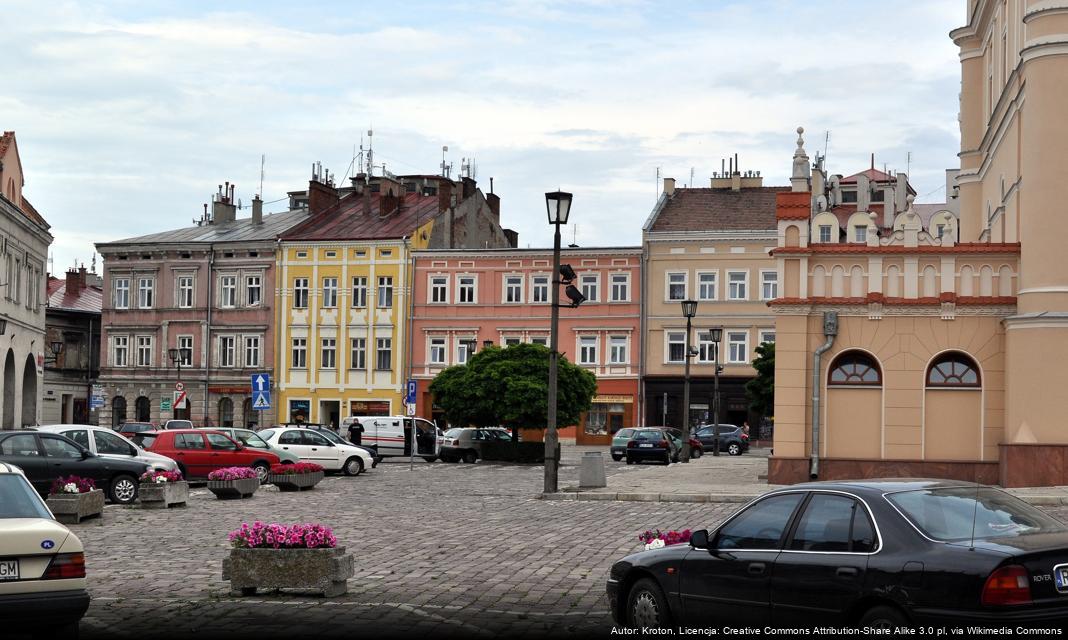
[132,428,279,482]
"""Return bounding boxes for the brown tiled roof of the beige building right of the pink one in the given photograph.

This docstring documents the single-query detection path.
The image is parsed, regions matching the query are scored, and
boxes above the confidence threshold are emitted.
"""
[649,187,790,232]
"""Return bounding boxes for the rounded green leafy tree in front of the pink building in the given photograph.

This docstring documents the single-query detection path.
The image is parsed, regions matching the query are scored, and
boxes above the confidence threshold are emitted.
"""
[430,344,597,438]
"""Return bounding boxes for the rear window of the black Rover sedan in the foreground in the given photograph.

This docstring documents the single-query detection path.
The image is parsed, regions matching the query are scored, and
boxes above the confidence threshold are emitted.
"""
[886,486,1068,542]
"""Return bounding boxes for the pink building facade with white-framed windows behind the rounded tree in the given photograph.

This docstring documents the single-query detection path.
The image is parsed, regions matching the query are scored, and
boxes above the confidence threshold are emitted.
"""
[409,247,642,444]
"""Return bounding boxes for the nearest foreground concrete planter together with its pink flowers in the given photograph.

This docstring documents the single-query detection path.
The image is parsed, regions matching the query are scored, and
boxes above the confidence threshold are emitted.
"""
[222,523,355,597]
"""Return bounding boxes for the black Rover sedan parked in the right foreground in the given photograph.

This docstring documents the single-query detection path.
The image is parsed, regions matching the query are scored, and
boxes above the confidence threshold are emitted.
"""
[608,480,1068,628]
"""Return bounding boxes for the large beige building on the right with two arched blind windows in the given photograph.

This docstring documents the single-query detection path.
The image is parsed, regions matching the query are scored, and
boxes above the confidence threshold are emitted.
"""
[769,1,1068,486]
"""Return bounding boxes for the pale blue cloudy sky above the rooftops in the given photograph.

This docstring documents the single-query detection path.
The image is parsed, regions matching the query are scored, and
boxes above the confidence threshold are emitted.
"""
[0,0,965,272]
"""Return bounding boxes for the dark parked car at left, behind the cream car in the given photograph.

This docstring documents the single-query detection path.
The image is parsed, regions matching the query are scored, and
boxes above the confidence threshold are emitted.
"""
[0,431,150,504]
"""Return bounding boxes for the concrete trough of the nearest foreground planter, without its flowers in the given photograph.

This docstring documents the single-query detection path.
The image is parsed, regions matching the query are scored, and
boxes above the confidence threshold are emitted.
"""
[222,547,356,597]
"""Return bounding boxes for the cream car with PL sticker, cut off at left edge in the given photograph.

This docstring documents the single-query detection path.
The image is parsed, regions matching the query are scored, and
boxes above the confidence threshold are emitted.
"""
[0,463,89,638]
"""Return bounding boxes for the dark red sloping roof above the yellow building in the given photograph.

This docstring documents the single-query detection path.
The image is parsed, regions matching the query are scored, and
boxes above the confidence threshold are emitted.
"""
[282,193,438,240]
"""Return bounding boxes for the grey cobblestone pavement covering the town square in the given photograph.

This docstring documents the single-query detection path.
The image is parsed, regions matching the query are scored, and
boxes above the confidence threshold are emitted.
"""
[29,448,1068,640]
